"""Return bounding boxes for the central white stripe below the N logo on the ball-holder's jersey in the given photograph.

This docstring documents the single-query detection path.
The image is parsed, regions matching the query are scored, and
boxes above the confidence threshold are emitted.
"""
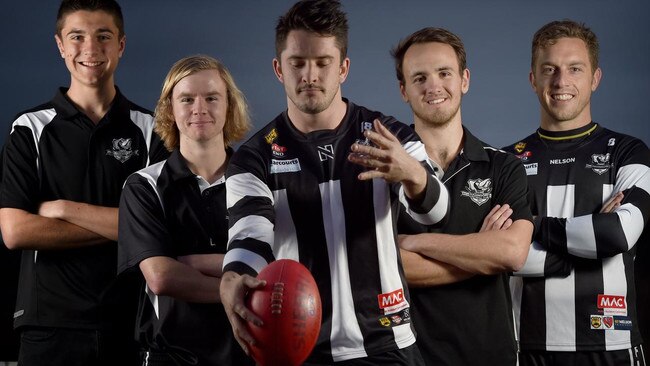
[318,180,367,362]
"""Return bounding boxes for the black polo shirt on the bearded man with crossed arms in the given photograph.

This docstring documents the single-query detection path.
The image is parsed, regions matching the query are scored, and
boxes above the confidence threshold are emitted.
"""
[398,128,532,365]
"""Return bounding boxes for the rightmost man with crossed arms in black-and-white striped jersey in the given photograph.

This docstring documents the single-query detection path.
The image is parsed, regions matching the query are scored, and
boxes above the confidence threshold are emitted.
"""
[507,20,650,365]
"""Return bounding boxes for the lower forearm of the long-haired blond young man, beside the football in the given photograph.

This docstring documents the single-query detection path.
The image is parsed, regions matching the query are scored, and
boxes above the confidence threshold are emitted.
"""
[140,257,221,303]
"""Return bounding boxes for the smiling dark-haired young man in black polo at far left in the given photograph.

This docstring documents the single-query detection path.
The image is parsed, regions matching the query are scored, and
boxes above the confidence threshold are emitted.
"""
[0,0,167,366]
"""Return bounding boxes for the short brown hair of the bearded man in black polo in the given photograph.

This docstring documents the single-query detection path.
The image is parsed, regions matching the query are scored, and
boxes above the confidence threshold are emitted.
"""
[390,27,467,85]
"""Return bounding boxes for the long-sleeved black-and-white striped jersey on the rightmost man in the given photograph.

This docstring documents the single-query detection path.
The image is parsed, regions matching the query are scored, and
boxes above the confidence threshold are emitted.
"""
[508,123,650,351]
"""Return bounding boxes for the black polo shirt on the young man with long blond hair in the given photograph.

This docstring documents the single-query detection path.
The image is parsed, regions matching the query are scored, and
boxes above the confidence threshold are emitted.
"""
[118,150,253,365]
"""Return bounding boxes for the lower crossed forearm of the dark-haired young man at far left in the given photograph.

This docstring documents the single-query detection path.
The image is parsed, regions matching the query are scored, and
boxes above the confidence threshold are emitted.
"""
[0,208,109,250]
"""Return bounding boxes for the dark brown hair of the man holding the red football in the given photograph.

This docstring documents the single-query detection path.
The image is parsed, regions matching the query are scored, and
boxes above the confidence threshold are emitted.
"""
[275,0,348,62]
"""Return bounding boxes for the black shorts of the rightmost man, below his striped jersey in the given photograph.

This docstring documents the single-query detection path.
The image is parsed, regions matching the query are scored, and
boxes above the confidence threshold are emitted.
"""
[519,345,646,366]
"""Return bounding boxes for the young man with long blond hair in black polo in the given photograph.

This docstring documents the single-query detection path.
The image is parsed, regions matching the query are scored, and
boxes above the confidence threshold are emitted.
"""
[118,56,253,366]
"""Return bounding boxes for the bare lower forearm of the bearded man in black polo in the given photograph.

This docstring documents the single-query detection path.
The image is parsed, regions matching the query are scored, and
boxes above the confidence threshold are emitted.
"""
[400,220,532,274]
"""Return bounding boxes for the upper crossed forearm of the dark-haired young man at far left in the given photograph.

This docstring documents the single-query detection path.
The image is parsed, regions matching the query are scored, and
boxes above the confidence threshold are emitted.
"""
[39,200,118,241]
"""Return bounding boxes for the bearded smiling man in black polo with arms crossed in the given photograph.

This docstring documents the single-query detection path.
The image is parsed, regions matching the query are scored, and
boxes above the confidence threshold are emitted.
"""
[392,28,533,366]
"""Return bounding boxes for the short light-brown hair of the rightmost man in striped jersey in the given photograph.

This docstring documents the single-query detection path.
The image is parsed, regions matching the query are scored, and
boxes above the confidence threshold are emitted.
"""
[530,19,600,71]
